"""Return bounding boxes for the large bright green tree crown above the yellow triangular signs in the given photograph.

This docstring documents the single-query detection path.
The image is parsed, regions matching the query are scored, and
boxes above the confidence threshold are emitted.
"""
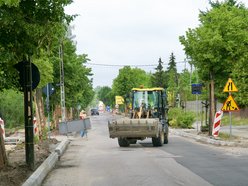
[179,0,248,107]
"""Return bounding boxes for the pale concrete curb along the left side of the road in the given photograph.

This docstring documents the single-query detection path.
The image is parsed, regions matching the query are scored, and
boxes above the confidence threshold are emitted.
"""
[22,139,69,186]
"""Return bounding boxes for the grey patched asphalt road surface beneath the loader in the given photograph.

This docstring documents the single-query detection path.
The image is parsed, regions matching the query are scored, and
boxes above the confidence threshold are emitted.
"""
[43,114,248,186]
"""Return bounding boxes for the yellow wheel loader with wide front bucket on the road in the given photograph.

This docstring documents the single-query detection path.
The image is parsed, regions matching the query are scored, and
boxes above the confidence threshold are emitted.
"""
[108,87,169,147]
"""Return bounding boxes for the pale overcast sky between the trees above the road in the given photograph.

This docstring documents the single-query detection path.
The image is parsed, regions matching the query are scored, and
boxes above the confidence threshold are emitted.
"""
[66,0,248,87]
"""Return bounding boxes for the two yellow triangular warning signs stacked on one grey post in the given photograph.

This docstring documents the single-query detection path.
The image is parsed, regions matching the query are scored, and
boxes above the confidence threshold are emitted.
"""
[221,78,239,137]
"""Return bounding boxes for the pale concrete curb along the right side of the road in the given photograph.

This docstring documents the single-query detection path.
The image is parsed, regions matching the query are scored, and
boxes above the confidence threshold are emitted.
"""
[170,129,248,147]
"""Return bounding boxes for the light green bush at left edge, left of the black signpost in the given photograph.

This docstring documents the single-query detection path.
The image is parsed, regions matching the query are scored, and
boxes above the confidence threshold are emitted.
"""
[0,89,24,128]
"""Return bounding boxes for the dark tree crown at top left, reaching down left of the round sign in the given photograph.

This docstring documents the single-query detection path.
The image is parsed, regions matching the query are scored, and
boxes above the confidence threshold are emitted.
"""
[0,0,75,88]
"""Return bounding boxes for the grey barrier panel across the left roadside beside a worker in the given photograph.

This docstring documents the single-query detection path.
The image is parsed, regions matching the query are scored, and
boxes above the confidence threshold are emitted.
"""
[59,117,91,134]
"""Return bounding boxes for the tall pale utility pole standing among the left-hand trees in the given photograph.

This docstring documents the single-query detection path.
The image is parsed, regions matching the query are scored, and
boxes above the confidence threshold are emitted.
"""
[59,41,66,122]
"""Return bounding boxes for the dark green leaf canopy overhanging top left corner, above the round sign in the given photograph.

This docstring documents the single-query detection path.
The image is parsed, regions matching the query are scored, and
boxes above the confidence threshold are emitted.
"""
[0,0,74,57]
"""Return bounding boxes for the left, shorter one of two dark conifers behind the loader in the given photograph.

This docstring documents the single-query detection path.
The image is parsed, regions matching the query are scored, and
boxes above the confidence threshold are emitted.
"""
[151,58,168,88]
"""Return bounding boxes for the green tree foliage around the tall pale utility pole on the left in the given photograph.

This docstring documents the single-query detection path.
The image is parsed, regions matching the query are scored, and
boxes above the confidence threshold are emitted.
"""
[51,39,94,109]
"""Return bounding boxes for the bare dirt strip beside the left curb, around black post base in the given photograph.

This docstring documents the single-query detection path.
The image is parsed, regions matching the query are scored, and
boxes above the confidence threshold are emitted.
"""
[0,138,58,186]
